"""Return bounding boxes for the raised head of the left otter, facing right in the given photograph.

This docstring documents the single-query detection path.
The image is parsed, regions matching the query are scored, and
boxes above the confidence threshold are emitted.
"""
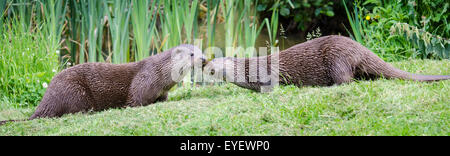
[171,45,207,82]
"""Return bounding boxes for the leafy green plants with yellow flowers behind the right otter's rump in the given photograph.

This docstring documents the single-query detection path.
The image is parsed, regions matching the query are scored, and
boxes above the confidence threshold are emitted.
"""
[347,0,448,61]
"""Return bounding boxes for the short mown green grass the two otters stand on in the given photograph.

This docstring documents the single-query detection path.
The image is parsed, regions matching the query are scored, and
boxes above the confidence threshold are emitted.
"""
[0,60,450,135]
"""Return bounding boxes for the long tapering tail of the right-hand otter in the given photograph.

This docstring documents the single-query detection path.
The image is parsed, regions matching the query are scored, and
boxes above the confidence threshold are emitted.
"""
[358,52,450,81]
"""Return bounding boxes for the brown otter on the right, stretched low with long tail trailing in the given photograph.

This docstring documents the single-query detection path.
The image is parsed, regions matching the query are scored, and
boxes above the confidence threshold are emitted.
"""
[204,35,450,92]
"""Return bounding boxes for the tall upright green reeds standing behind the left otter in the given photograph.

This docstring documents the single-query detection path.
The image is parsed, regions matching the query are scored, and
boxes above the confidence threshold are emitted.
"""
[0,0,276,63]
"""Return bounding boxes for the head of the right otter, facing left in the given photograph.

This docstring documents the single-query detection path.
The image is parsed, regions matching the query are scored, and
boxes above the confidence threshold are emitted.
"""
[203,57,239,82]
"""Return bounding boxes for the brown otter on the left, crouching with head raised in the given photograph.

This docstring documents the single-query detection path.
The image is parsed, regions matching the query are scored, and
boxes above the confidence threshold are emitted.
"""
[0,45,206,125]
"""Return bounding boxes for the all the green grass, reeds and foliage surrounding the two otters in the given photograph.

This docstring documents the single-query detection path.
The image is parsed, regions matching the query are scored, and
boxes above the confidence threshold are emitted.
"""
[0,0,450,135]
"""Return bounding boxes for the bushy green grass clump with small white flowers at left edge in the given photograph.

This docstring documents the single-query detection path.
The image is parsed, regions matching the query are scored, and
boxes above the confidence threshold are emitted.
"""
[0,20,59,107]
